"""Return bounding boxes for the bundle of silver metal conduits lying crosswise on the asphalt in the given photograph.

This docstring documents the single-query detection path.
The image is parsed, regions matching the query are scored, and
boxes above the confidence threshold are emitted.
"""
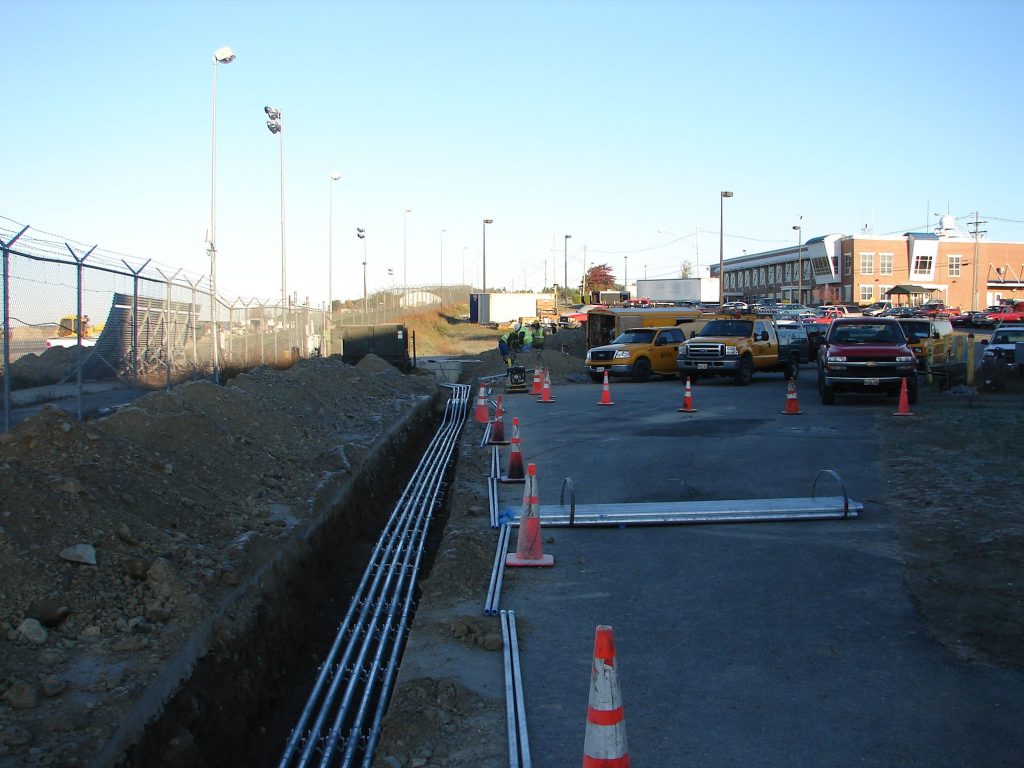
[524,496,864,526]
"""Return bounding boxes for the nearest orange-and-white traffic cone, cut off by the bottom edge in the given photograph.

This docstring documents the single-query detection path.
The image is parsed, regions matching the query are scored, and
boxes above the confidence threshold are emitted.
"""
[583,625,630,768]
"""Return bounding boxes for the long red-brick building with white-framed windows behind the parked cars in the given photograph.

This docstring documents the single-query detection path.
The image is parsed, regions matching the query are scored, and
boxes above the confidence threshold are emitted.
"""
[711,216,1024,310]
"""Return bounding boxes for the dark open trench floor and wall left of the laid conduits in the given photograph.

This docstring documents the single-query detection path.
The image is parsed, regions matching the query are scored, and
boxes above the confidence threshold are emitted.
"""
[99,391,452,768]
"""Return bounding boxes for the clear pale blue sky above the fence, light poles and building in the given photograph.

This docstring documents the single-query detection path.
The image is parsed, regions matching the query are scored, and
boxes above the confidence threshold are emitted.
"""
[0,0,1024,304]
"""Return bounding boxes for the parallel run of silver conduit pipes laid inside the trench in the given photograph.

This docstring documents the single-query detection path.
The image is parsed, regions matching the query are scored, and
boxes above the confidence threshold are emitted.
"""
[279,384,471,768]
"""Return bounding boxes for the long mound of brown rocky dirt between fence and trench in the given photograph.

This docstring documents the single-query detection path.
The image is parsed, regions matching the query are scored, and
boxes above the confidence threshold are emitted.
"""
[0,357,436,765]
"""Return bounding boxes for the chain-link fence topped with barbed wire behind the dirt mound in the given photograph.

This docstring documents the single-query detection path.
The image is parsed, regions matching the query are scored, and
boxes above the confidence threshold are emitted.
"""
[0,217,468,429]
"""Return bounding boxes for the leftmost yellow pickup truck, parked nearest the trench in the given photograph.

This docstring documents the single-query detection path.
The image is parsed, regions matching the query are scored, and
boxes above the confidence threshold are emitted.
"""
[587,326,686,381]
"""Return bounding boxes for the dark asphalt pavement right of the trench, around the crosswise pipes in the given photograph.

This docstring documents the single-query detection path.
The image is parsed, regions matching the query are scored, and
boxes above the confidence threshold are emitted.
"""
[481,367,1024,768]
